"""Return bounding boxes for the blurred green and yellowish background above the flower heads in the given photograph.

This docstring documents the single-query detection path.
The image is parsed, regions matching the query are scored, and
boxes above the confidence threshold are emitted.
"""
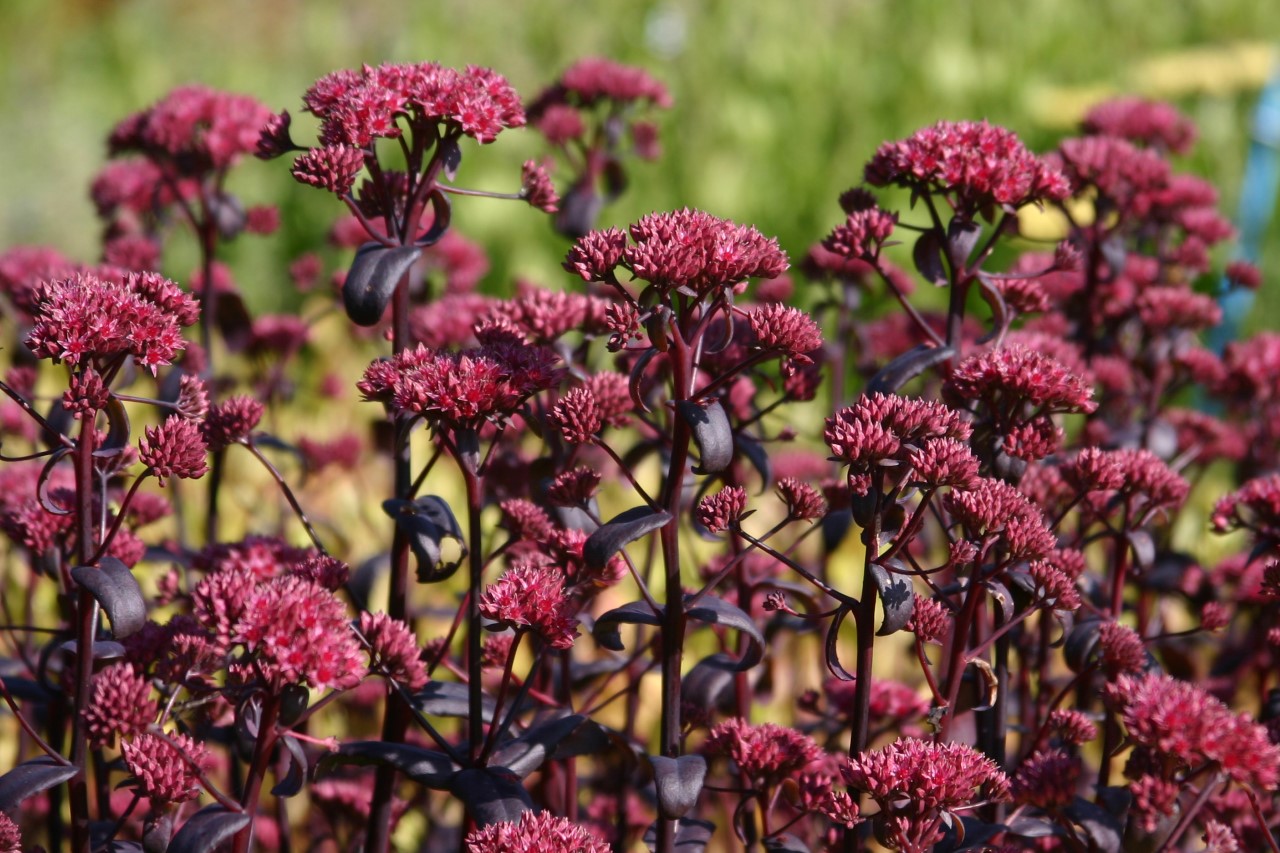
[0,0,1280,317]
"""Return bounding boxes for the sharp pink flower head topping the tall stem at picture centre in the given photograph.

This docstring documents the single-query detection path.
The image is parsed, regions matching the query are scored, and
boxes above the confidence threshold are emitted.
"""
[564,207,787,301]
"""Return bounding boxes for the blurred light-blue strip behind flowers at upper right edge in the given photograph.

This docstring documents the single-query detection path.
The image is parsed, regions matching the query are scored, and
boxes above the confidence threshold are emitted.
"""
[1210,61,1280,353]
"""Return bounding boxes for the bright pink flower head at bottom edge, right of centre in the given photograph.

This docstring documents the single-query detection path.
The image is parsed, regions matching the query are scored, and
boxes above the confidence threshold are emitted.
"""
[841,738,1009,850]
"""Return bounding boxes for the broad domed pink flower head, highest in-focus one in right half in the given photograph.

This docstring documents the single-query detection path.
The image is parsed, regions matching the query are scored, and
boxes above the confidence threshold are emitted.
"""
[865,122,1070,215]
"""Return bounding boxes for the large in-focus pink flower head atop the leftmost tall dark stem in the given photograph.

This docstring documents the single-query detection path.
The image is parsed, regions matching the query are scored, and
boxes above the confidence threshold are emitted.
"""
[26,267,200,374]
